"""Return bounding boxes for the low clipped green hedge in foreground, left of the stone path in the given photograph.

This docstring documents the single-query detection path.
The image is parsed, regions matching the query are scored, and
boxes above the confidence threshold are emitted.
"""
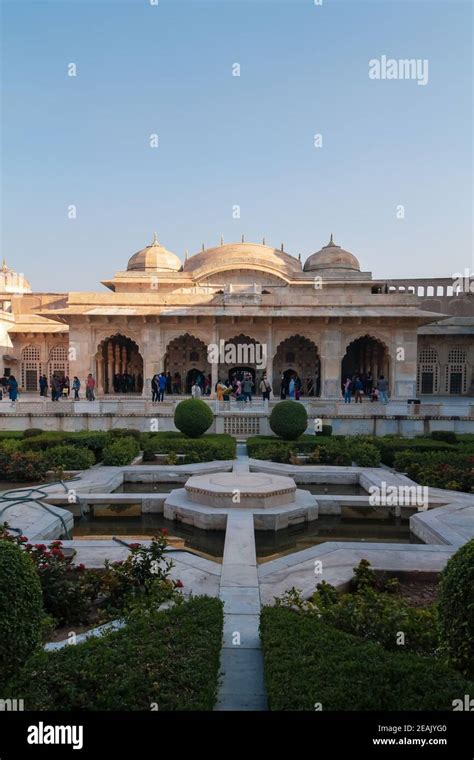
[11,597,223,712]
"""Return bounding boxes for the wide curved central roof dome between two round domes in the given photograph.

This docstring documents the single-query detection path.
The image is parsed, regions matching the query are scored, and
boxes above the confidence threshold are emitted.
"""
[184,240,301,277]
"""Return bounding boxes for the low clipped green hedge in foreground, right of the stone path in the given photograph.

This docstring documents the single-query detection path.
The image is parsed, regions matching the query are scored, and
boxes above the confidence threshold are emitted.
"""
[260,607,474,711]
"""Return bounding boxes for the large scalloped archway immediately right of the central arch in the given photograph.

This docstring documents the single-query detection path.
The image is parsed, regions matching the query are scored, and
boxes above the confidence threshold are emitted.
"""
[273,335,321,396]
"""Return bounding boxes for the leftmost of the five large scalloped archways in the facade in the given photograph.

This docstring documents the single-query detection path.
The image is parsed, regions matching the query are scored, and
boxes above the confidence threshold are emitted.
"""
[97,333,143,393]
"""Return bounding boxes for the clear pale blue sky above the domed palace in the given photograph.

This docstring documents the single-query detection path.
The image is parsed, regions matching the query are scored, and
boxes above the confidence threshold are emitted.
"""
[1,0,473,291]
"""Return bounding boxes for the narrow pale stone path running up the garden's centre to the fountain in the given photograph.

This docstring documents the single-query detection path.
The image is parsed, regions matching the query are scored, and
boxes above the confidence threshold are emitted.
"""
[214,444,267,711]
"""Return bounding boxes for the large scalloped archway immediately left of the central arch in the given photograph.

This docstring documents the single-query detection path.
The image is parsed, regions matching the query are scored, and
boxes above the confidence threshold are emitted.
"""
[164,333,211,393]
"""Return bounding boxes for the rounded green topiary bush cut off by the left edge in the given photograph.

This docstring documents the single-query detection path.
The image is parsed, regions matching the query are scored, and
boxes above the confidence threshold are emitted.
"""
[0,541,44,686]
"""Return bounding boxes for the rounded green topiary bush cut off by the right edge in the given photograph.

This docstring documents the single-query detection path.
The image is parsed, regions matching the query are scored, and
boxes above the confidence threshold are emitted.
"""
[438,539,474,678]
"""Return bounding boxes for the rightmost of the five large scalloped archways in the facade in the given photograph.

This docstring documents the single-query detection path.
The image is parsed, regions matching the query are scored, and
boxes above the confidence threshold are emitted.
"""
[341,335,391,392]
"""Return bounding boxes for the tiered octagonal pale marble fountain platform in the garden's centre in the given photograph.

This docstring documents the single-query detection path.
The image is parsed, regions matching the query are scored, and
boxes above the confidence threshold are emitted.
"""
[163,465,318,530]
